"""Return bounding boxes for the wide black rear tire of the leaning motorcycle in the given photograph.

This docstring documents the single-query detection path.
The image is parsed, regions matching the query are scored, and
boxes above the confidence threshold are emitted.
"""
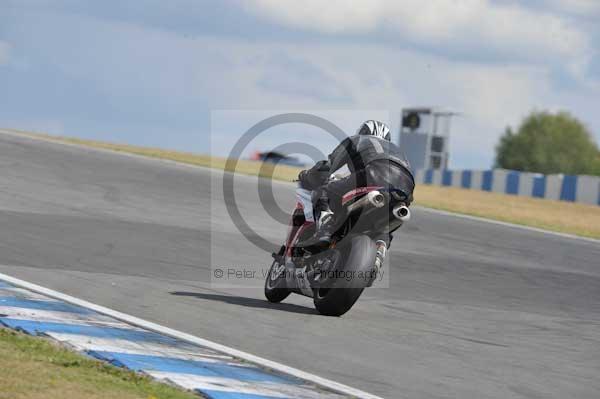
[314,235,376,316]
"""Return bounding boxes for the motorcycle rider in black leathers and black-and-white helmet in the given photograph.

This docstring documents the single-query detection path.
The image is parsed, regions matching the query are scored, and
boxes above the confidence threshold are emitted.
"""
[298,120,415,248]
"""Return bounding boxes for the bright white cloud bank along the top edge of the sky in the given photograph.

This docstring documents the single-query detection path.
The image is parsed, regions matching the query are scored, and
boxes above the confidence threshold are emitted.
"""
[244,0,589,60]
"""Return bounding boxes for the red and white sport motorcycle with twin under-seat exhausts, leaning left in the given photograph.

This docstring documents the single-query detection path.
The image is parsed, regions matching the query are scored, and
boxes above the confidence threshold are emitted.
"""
[265,180,410,316]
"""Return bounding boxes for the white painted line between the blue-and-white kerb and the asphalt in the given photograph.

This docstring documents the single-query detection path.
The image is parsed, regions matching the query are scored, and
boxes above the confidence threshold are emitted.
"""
[0,273,382,399]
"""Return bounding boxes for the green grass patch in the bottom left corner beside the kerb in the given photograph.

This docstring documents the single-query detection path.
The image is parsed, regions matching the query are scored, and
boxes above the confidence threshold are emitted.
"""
[0,328,198,399]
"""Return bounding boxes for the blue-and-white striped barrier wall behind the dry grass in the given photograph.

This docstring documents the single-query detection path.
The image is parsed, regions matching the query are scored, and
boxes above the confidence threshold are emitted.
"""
[415,169,600,205]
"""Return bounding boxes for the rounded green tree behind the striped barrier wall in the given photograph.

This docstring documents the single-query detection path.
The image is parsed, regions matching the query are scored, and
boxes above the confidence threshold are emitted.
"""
[495,111,600,175]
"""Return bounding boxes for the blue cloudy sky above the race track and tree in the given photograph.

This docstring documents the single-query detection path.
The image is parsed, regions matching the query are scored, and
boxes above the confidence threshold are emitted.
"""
[0,0,600,168]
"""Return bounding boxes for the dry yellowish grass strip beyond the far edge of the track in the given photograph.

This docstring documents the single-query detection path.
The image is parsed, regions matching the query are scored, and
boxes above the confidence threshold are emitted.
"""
[4,130,600,238]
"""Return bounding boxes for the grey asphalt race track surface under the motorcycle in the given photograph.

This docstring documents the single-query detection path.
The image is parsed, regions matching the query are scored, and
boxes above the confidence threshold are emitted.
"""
[0,134,600,399]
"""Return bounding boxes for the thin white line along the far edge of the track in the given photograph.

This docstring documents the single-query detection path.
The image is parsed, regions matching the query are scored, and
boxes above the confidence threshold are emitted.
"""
[0,128,600,244]
